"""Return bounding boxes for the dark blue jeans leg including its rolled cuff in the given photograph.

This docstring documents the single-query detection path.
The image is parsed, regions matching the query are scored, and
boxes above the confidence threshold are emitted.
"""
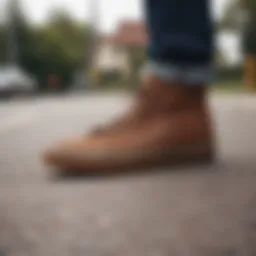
[145,0,213,84]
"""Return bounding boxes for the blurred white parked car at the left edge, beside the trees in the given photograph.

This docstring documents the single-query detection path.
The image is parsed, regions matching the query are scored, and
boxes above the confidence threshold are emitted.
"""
[0,67,37,97]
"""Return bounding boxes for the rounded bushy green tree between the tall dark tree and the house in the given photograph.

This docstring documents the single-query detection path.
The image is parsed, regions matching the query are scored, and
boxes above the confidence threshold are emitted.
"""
[24,10,90,91]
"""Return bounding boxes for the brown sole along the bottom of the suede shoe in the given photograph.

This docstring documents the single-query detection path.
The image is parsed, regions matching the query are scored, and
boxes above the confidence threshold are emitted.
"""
[44,145,215,177]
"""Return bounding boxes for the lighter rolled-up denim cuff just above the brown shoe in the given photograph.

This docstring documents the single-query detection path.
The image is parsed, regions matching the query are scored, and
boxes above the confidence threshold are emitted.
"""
[143,62,215,85]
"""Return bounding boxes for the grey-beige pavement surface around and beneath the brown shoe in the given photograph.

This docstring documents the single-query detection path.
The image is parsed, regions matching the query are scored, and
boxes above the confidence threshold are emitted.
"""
[0,94,256,256]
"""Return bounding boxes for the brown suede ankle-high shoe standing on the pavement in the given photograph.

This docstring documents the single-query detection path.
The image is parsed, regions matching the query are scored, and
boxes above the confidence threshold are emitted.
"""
[44,77,213,175]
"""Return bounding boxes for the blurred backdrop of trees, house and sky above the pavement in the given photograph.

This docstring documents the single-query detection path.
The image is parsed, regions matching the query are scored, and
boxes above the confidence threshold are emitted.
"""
[0,0,252,96]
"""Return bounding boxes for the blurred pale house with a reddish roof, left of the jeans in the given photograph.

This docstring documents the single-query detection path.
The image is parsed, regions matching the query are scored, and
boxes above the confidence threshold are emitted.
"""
[94,20,148,75]
